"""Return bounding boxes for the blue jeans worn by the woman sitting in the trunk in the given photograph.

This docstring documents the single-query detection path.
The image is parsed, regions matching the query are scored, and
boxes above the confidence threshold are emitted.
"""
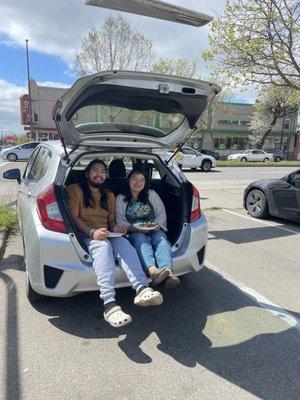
[129,229,172,271]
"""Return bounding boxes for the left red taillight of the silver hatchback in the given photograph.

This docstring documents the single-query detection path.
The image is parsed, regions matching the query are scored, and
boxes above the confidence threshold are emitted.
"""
[37,185,67,233]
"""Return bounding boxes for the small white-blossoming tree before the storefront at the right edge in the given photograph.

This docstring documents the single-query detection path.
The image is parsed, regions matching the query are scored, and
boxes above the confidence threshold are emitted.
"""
[249,86,300,148]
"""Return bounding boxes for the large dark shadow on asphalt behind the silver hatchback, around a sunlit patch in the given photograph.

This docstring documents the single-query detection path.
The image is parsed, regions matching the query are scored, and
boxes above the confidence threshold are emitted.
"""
[31,268,300,400]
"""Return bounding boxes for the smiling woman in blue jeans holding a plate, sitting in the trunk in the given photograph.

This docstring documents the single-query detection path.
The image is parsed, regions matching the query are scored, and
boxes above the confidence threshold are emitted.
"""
[116,169,180,289]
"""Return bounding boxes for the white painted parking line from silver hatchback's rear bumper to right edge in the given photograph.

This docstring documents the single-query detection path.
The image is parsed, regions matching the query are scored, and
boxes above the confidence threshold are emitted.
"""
[205,262,300,331]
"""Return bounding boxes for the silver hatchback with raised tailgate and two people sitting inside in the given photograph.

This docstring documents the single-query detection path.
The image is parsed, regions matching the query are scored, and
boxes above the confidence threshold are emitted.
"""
[4,71,220,302]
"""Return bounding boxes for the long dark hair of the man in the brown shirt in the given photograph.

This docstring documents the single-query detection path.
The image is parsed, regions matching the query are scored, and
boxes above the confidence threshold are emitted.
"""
[79,158,108,210]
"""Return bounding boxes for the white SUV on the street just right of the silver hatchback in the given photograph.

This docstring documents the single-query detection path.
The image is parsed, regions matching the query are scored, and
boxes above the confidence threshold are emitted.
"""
[165,146,216,172]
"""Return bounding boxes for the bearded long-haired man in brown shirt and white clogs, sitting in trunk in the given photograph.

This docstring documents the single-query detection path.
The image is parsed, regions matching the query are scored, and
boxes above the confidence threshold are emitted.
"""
[67,159,163,327]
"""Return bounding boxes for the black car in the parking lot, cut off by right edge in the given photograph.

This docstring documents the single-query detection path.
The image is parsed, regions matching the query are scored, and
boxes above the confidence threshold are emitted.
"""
[244,169,300,222]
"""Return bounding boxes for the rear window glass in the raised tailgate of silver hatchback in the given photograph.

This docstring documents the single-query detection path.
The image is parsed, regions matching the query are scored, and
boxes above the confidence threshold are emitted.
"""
[72,105,185,137]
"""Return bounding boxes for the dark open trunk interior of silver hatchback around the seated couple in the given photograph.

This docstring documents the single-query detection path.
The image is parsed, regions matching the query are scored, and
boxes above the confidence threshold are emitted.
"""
[61,152,192,251]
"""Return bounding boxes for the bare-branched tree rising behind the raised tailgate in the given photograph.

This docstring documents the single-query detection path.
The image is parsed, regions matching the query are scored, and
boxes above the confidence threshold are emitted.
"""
[75,16,153,76]
